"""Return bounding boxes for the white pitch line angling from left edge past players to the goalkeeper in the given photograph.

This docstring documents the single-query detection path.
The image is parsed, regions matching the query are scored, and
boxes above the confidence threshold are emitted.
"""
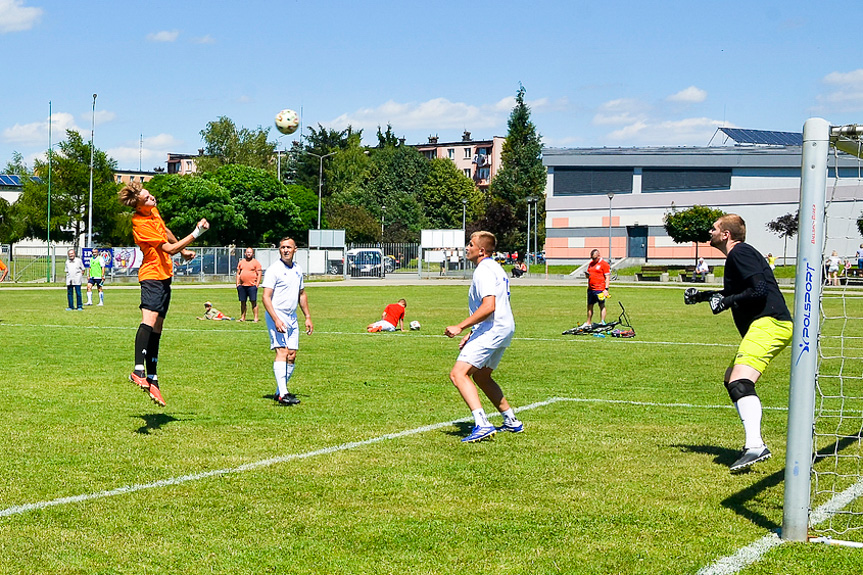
[0,397,768,517]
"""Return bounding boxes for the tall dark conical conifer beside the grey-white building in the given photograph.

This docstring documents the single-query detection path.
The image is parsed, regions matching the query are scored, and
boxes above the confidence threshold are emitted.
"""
[490,85,546,251]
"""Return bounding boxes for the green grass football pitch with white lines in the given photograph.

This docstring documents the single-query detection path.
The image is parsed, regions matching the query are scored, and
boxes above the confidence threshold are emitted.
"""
[0,282,863,575]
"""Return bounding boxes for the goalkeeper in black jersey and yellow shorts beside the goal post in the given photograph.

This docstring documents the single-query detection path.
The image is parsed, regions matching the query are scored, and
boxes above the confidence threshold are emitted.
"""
[683,214,792,471]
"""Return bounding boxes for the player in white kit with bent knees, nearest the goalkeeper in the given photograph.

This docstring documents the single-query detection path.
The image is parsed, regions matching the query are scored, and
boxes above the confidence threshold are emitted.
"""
[444,232,524,443]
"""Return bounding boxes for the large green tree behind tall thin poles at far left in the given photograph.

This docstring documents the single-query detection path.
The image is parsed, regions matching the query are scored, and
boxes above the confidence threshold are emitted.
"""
[16,130,126,245]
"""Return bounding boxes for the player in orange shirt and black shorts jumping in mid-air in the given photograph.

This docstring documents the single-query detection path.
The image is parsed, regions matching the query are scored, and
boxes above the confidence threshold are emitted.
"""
[118,183,210,405]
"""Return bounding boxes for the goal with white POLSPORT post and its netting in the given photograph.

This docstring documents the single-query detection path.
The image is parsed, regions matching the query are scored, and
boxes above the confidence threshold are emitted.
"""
[782,118,863,546]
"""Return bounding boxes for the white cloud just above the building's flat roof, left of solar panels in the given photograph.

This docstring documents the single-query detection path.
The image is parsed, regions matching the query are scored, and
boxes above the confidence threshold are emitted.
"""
[608,118,724,146]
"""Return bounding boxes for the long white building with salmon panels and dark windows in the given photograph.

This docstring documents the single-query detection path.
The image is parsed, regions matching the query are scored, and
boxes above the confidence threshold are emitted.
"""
[543,129,863,265]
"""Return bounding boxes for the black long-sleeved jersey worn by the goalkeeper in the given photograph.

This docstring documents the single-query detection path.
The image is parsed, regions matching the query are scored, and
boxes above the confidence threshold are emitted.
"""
[722,242,791,336]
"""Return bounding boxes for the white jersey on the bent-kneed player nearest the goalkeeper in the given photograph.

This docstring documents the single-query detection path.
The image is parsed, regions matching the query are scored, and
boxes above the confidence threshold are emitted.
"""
[468,258,515,347]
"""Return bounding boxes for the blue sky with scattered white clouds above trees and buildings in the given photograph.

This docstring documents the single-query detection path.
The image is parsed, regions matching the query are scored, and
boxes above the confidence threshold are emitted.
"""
[0,0,863,170]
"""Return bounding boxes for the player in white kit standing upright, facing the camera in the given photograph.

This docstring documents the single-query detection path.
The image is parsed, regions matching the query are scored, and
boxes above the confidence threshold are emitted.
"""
[261,238,314,405]
